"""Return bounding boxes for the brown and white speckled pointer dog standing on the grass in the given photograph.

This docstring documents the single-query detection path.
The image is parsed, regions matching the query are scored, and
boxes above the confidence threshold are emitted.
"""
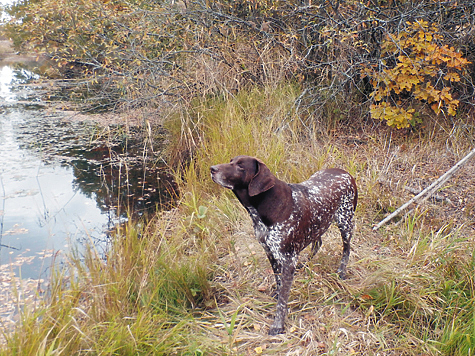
[211,156,358,335]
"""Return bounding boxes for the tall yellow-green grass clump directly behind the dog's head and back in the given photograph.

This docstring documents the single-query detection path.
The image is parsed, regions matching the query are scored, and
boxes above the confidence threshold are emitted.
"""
[168,85,351,200]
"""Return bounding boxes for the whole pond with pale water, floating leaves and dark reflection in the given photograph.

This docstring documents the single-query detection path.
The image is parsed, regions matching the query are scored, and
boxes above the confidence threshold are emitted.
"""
[0,61,175,280]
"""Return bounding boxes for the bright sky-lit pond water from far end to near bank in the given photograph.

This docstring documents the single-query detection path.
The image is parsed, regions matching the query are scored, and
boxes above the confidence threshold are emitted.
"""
[0,66,114,278]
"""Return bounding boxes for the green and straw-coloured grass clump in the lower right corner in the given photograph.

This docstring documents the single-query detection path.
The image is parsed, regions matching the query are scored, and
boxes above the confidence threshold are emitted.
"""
[357,222,475,355]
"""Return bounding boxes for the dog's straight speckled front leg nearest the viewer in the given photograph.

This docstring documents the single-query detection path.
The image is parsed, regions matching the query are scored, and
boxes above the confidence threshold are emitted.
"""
[269,256,297,335]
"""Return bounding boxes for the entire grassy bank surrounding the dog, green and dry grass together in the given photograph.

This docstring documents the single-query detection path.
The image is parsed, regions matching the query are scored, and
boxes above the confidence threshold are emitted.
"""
[1,85,475,355]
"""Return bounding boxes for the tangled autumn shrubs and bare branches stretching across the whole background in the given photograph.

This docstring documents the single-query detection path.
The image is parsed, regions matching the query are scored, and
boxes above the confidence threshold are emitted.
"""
[5,0,475,127]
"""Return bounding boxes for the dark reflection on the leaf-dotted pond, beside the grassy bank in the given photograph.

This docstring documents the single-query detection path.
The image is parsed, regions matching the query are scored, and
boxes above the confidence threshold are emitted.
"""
[72,140,176,218]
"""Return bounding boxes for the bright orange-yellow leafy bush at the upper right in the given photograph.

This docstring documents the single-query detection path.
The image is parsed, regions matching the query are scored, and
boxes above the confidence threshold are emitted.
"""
[366,20,469,128]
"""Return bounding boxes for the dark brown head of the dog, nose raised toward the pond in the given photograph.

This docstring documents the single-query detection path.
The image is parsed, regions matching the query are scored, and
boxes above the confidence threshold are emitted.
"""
[211,156,275,197]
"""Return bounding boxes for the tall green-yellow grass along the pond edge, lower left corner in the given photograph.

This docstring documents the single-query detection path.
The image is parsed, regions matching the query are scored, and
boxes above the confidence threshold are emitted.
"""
[2,218,225,355]
